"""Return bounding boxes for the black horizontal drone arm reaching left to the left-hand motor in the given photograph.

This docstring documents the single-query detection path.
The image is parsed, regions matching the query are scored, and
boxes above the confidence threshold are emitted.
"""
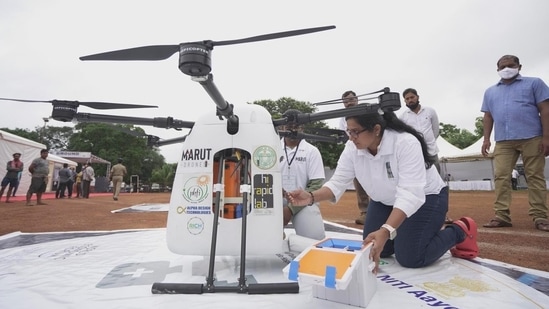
[71,113,194,129]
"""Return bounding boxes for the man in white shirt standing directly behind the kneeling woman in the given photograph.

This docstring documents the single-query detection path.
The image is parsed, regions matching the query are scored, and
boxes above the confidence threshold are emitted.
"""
[400,88,452,224]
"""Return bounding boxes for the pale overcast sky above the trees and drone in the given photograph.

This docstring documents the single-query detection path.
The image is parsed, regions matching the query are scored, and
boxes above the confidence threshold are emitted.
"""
[0,0,549,162]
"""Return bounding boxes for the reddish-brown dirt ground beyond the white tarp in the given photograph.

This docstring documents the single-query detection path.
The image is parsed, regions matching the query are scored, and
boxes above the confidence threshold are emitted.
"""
[0,190,549,271]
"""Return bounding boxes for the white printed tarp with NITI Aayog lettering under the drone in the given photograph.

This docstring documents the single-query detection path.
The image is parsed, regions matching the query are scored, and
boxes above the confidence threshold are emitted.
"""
[0,225,549,309]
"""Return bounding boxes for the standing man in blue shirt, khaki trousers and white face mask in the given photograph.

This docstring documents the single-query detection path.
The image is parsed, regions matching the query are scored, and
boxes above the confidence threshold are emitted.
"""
[481,55,549,232]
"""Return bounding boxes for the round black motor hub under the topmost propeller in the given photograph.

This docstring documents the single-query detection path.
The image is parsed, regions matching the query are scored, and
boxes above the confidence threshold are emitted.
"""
[179,43,212,76]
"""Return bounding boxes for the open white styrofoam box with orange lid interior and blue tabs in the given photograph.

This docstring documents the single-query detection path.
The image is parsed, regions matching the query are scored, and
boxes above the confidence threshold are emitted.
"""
[283,238,377,308]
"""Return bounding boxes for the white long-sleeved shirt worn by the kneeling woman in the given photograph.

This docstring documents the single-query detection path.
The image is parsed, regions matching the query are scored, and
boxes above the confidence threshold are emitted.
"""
[324,129,446,217]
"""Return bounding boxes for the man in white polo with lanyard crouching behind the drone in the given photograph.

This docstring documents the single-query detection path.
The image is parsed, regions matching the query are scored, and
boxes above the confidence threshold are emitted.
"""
[280,110,326,240]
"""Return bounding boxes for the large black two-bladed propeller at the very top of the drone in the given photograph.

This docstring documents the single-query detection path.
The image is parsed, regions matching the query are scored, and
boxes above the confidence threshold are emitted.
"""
[80,26,335,61]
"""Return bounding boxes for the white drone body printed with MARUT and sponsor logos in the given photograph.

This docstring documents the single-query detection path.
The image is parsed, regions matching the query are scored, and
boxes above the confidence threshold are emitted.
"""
[167,104,283,255]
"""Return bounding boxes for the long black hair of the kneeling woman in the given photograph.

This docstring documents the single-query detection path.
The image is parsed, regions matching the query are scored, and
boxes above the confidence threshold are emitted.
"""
[345,112,435,169]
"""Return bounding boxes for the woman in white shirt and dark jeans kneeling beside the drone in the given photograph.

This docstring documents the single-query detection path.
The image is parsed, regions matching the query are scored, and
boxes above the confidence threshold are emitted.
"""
[288,112,478,273]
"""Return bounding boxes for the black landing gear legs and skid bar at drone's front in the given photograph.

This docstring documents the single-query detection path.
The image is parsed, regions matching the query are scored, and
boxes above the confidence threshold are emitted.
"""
[151,153,299,294]
